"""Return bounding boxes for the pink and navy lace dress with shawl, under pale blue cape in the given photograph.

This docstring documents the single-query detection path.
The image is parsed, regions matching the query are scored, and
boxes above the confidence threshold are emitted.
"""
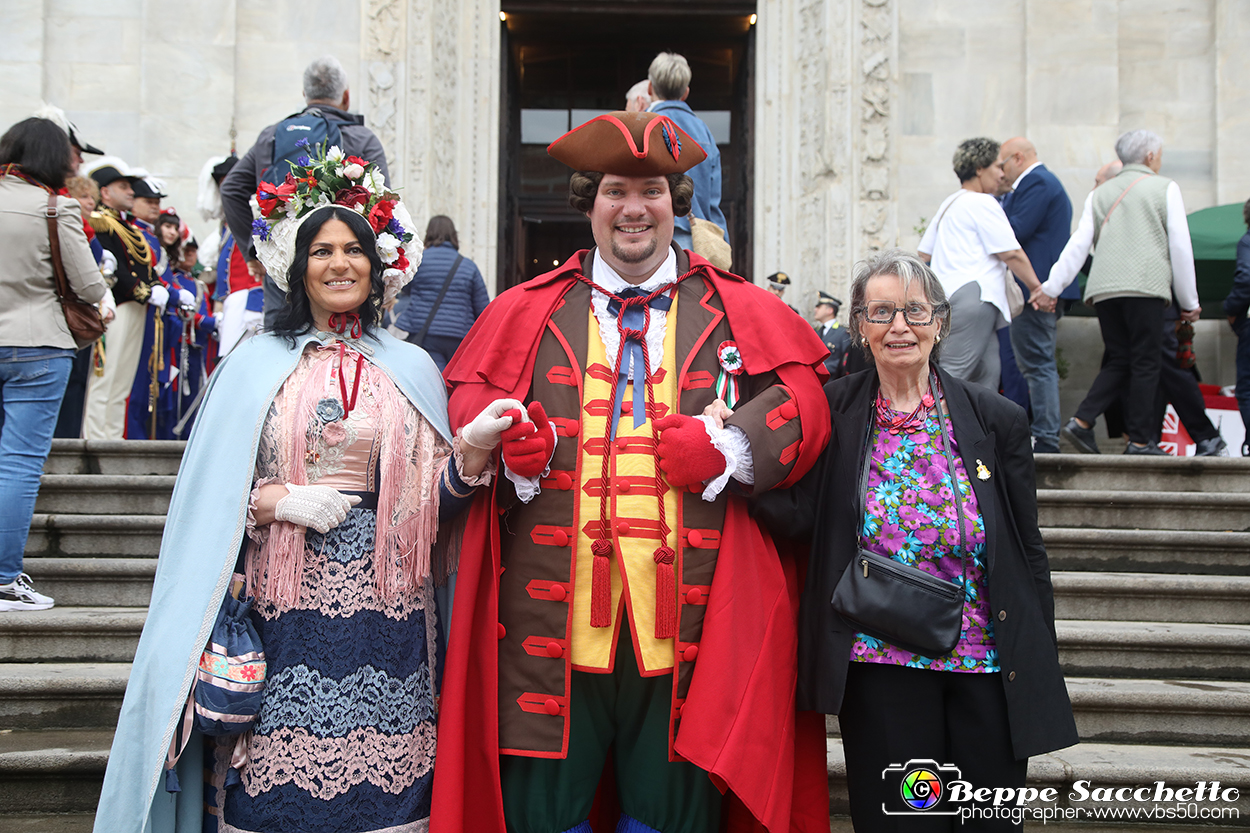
[209,344,471,833]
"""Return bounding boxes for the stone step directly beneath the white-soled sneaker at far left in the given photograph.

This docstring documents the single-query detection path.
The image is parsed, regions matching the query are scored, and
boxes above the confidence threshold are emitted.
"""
[0,607,148,663]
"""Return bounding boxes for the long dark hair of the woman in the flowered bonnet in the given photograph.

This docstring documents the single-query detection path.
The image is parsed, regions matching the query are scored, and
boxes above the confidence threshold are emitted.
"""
[265,205,385,346]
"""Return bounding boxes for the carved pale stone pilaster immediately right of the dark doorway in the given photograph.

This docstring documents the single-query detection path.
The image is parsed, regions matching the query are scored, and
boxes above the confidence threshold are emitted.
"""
[753,0,850,314]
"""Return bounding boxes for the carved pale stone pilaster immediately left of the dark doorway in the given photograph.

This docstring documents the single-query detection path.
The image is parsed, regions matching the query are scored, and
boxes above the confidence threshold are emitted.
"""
[392,0,501,290]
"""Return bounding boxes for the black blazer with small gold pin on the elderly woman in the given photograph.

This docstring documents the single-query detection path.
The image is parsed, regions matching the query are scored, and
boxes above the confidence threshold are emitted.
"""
[754,369,1078,759]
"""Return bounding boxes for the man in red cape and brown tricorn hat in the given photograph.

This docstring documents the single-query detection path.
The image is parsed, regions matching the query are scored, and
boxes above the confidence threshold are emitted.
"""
[431,113,830,833]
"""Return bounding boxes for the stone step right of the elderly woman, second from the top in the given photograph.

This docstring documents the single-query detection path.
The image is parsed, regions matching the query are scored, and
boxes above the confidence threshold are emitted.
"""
[1038,489,1250,532]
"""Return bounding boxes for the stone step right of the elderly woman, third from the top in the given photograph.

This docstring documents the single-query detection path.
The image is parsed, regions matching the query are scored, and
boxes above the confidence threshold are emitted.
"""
[1041,527,1250,575]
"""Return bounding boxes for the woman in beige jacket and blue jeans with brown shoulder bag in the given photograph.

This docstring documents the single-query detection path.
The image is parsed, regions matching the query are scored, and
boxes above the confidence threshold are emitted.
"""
[0,119,108,610]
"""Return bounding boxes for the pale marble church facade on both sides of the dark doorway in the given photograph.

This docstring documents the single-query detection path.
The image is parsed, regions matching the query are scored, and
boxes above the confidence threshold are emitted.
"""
[0,0,1250,382]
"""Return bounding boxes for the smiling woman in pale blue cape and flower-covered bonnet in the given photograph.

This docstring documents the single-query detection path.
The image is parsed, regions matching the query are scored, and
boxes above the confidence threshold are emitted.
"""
[95,148,541,833]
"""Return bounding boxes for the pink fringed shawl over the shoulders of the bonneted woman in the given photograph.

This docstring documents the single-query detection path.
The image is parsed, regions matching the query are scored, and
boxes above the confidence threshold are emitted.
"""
[246,344,451,609]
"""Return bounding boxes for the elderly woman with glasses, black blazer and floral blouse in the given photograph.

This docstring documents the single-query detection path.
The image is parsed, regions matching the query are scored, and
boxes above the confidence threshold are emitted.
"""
[756,250,1078,833]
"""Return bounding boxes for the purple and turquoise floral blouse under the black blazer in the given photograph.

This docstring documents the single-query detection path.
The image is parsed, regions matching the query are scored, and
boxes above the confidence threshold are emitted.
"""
[851,413,999,673]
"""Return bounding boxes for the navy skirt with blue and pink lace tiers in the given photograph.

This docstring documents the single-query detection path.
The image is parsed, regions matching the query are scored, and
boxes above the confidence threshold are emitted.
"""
[216,508,436,833]
